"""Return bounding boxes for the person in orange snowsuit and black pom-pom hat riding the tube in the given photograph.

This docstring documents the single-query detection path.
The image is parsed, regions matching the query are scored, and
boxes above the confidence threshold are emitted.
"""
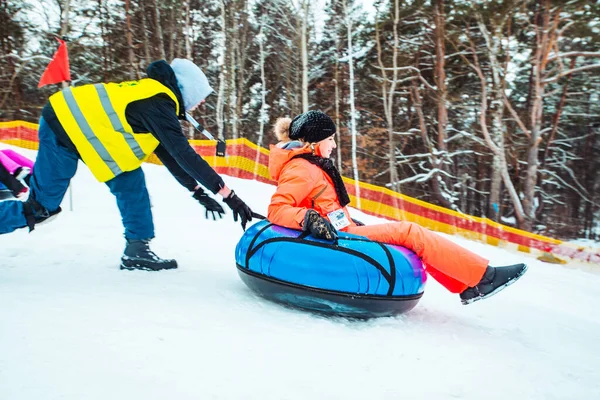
[268,111,527,304]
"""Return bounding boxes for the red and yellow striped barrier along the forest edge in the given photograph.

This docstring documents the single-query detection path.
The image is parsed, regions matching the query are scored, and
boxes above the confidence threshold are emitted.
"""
[0,121,600,264]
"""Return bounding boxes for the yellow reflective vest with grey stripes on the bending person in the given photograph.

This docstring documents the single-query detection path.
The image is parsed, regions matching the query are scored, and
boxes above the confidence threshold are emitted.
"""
[50,79,179,182]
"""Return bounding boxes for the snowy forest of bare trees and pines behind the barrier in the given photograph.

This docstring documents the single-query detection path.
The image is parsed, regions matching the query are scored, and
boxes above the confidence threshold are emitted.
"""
[0,0,600,240]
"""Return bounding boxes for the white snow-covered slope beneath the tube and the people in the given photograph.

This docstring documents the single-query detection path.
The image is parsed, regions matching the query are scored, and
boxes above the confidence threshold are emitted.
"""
[0,145,600,400]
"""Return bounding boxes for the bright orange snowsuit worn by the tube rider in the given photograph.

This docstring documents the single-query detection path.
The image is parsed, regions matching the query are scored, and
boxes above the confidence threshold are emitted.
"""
[268,146,488,293]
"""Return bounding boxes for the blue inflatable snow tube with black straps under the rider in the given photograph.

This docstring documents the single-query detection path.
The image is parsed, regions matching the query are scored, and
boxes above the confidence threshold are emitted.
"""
[235,221,427,318]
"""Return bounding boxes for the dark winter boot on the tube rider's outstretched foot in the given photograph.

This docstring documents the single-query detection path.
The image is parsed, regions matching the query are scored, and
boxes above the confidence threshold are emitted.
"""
[460,264,527,305]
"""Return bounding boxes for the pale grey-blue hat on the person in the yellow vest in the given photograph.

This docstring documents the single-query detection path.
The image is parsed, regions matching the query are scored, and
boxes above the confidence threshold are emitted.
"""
[171,58,213,111]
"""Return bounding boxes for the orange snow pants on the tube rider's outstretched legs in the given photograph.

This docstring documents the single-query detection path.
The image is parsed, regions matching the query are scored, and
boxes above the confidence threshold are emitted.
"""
[346,222,488,293]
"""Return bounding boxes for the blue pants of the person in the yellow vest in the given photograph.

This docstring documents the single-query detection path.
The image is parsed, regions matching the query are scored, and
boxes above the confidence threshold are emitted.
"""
[0,118,154,239]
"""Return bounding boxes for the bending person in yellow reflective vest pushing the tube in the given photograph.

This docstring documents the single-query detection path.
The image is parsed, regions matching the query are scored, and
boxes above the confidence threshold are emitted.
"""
[0,59,252,271]
